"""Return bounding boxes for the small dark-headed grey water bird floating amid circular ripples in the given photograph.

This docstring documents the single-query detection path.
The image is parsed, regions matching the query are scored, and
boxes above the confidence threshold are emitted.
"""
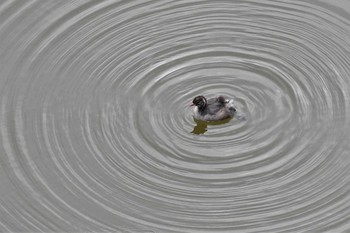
[191,95,236,121]
